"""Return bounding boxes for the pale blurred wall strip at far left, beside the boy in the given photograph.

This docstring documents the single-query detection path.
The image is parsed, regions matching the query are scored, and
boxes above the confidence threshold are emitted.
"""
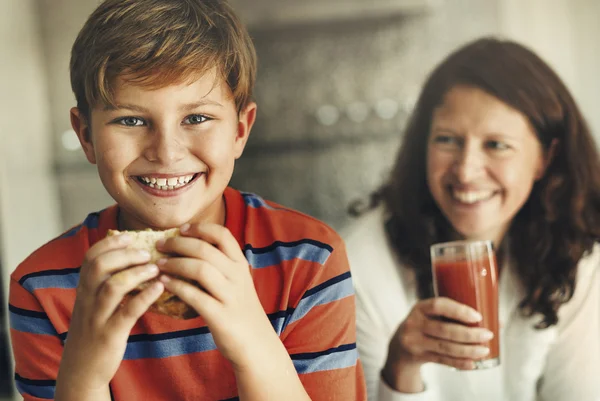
[0,0,62,396]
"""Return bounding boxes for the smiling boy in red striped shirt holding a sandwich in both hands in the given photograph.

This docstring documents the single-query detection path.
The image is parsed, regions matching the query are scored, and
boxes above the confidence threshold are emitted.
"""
[10,0,366,401]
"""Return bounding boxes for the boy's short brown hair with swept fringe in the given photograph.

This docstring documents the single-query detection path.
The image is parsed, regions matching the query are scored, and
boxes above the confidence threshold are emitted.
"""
[70,0,256,121]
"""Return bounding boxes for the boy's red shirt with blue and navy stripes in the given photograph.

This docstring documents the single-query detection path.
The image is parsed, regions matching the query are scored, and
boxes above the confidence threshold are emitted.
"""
[9,188,366,401]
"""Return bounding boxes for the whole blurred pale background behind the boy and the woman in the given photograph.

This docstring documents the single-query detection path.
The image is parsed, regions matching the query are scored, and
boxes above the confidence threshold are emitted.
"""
[0,0,600,399]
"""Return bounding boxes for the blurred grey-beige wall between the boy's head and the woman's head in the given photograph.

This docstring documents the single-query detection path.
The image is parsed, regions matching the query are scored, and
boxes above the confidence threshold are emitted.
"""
[233,0,500,228]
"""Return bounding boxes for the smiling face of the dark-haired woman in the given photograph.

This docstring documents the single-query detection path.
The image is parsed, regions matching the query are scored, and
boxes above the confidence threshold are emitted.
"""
[427,86,546,244]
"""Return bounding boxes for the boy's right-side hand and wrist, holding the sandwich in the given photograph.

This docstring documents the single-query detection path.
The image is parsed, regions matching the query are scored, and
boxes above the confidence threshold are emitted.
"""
[157,224,278,370]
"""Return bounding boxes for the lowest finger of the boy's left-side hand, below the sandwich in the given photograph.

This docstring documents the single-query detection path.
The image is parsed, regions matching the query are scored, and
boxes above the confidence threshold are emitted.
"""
[109,281,165,333]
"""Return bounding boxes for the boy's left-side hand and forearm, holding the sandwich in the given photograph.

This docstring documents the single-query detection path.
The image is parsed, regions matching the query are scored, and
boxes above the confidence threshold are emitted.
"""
[57,234,164,399]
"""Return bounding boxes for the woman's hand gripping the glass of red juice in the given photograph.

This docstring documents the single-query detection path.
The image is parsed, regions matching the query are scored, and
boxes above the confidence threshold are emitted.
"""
[382,297,493,393]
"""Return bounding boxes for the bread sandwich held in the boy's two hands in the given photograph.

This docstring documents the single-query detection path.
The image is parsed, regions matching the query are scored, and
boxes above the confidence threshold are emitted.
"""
[107,228,198,319]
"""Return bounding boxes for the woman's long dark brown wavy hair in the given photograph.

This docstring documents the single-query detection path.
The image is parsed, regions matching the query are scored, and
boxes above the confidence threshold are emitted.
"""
[373,38,600,328]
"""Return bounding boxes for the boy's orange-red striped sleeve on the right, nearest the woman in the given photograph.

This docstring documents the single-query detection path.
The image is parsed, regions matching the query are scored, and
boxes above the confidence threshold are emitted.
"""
[281,239,367,401]
